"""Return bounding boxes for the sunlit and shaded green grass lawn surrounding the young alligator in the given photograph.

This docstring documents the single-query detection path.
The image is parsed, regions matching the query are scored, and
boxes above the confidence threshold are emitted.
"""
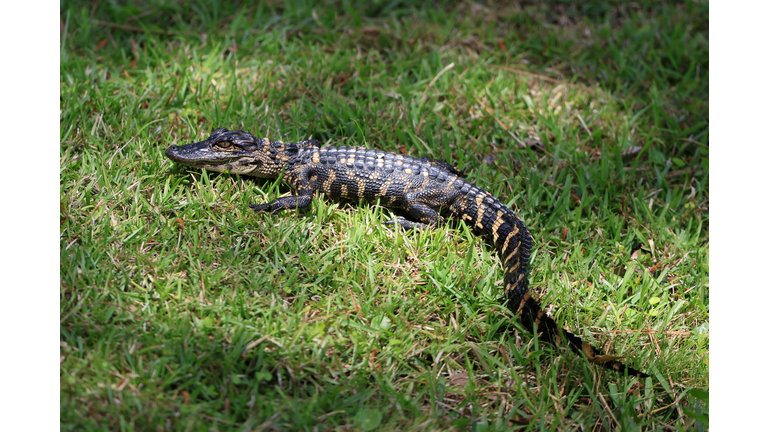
[60,1,709,431]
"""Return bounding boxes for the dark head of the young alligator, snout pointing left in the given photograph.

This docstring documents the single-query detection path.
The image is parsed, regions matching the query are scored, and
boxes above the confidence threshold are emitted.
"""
[165,128,286,178]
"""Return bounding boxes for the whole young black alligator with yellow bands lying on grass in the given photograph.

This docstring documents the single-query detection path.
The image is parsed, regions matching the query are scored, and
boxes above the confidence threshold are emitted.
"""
[165,128,648,377]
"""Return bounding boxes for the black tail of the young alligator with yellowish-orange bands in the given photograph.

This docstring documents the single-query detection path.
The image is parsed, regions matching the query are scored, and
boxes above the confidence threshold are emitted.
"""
[462,191,649,378]
